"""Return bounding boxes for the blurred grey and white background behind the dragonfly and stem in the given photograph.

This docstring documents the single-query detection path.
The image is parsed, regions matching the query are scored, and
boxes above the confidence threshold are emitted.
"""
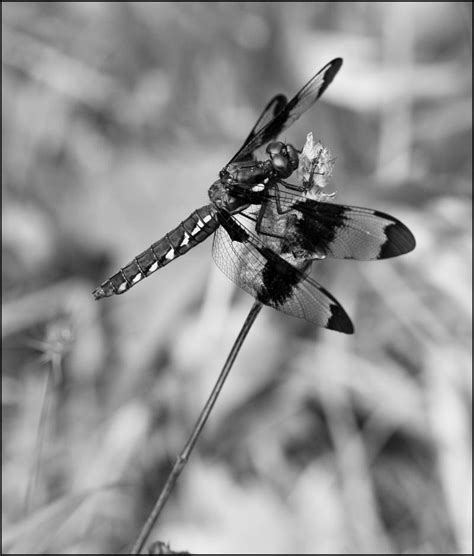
[2,2,472,554]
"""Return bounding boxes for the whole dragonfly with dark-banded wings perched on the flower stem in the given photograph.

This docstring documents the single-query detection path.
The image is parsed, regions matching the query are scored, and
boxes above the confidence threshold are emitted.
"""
[93,58,415,334]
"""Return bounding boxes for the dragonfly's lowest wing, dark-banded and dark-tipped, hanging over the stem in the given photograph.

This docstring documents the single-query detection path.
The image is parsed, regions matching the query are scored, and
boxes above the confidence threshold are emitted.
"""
[212,214,354,334]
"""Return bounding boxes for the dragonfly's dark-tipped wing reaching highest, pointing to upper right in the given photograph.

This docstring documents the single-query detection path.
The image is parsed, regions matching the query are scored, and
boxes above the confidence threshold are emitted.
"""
[233,58,342,160]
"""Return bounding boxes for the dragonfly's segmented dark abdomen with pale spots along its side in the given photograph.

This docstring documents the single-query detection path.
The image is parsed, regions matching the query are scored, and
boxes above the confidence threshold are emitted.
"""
[92,205,219,299]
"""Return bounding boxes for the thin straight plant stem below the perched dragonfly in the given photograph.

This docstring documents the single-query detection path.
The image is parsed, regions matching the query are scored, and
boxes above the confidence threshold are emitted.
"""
[130,301,262,554]
